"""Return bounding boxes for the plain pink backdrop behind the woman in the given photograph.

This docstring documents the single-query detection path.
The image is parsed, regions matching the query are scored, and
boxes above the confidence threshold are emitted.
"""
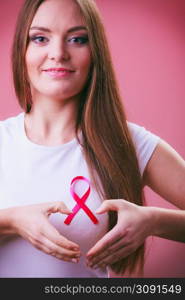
[0,0,185,277]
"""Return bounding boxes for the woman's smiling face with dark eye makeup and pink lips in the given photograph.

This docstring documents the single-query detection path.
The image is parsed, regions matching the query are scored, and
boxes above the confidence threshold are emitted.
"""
[26,0,91,99]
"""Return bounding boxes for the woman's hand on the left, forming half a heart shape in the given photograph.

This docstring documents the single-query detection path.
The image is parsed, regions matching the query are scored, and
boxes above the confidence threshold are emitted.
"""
[9,201,80,262]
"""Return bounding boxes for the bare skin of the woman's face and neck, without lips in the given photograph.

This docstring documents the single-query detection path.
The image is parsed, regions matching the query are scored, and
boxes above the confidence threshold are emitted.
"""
[25,0,91,146]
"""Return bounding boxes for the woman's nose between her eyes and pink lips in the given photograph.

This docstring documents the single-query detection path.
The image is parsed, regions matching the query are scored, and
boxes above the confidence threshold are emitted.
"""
[48,41,70,62]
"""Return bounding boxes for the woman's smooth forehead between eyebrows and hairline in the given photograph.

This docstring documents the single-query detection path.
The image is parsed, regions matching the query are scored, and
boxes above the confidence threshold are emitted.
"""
[31,0,85,28]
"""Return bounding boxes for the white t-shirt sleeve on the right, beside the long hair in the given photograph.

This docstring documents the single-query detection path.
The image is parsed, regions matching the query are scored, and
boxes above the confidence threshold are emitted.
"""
[127,122,161,176]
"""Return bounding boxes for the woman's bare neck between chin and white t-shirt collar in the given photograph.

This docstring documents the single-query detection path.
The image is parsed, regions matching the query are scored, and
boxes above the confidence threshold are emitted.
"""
[25,95,78,146]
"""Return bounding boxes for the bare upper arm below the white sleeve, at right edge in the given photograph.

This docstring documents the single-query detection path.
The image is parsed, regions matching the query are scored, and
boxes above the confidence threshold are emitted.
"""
[143,140,185,209]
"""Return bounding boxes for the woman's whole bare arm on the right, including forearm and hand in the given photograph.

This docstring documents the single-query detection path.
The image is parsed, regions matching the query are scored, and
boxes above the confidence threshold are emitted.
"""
[87,141,185,267]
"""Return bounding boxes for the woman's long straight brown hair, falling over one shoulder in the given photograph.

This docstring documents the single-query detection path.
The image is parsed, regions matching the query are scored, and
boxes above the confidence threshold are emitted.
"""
[12,0,144,275]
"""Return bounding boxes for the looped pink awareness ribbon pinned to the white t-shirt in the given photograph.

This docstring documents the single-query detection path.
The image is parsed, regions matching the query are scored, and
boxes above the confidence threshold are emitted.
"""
[64,176,98,225]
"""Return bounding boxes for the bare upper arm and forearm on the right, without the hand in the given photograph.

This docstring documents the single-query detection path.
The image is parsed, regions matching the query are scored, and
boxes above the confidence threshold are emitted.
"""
[143,141,185,242]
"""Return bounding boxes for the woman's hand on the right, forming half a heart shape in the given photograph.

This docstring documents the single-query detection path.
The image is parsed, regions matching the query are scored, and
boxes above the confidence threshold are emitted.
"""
[86,199,153,269]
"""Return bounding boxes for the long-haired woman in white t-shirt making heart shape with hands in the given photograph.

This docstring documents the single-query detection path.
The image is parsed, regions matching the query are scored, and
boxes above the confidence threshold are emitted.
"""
[0,0,185,277]
